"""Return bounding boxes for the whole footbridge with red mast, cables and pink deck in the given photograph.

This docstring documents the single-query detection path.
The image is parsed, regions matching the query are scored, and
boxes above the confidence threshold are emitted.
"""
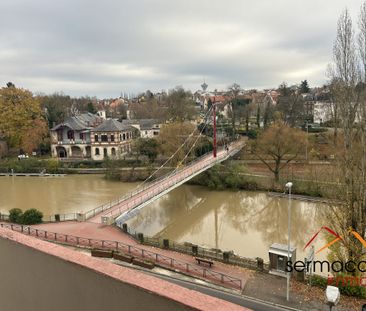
[83,105,246,225]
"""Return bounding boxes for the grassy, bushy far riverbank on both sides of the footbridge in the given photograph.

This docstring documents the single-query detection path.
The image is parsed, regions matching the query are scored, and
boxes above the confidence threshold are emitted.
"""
[0,158,335,198]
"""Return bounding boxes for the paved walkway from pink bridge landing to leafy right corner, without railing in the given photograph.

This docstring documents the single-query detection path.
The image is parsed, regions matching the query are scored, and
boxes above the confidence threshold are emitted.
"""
[4,222,366,311]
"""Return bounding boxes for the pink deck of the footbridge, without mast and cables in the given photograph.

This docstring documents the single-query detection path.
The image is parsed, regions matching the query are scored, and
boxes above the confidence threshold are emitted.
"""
[86,140,245,224]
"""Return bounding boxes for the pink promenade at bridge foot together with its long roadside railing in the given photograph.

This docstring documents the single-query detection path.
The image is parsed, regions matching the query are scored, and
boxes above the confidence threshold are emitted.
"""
[1,221,251,291]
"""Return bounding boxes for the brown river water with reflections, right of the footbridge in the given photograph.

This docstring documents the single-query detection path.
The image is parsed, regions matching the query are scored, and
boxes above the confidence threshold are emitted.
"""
[129,185,325,258]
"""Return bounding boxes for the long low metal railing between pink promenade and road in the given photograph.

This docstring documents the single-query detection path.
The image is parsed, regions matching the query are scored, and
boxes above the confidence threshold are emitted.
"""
[0,223,242,289]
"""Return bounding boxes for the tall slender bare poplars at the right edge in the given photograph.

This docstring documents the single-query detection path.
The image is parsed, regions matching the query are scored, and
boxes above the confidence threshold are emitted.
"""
[330,4,366,262]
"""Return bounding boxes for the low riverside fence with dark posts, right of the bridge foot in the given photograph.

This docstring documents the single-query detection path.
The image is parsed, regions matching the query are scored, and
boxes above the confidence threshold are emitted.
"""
[119,224,269,272]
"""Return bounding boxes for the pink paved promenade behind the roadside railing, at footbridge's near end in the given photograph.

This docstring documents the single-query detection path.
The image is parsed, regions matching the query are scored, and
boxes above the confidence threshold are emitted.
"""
[32,221,251,288]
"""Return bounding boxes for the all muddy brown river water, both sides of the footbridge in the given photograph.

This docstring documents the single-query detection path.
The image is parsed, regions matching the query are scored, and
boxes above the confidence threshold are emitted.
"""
[0,175,327,261]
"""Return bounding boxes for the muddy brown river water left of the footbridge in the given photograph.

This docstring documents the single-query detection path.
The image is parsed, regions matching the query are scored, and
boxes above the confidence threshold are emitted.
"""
[0,175,136,215]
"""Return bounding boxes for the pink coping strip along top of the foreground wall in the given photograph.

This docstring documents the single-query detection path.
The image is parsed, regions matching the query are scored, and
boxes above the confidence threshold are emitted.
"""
[0,228,249,311]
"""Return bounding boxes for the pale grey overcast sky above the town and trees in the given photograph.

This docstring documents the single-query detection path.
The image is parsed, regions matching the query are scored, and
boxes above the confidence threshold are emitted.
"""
[0,0,362,98]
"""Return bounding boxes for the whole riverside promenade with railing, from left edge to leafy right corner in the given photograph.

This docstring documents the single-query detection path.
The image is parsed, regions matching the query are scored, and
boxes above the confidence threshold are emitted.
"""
[0,221,366,311]
